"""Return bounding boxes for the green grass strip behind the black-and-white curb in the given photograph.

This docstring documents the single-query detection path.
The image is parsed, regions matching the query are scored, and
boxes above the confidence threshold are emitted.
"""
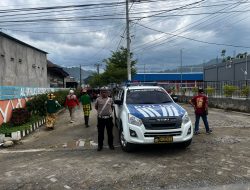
[0,115,42,134]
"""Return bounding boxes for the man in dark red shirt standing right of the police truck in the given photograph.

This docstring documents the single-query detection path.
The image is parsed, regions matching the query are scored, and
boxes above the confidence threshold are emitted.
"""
[189,88,212,135]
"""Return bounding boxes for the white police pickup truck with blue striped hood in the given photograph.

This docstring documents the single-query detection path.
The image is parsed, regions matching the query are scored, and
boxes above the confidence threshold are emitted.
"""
[114,86,193,152]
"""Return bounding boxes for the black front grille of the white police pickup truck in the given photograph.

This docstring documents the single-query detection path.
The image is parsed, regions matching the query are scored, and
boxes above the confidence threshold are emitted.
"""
[142,117,182,130]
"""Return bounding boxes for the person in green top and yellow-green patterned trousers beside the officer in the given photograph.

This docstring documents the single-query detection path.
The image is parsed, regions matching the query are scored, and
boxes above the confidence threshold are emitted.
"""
[80,89,92,127]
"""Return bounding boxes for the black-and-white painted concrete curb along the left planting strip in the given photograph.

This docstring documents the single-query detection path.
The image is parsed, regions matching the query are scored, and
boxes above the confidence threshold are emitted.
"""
[0,118,45,142]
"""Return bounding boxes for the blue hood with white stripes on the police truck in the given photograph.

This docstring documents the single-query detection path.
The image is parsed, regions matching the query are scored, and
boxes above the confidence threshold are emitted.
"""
[127,103,186,119]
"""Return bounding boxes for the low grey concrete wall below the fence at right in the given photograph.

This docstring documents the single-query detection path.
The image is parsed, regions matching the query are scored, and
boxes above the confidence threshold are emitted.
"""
[179,96,250,113]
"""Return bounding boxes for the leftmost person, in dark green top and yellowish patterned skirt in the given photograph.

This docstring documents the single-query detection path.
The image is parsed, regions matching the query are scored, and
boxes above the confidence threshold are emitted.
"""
[45,93,61,129]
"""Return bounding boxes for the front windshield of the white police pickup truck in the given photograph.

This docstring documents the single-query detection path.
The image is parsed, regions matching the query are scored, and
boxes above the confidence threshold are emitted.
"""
[126,89,172,104]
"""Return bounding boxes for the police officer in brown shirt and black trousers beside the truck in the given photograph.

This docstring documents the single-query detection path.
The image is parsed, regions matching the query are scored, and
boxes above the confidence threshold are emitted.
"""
[95,87,114,151]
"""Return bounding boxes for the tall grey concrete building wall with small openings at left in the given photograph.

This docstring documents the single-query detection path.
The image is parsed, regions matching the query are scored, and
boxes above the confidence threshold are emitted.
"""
[0,36,48,87]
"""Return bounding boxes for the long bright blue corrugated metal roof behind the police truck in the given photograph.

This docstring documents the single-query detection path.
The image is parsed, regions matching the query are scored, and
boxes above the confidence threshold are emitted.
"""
[132,72,203,81]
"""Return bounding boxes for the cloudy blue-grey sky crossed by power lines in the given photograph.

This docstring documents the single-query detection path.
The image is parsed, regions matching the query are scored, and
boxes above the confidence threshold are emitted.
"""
[0,0,250,72]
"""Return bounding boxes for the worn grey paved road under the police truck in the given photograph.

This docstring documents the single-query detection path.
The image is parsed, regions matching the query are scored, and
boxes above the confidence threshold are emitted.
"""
[0,105,250,190]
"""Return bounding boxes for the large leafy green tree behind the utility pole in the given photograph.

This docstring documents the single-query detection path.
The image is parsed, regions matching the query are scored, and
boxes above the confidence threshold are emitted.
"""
[90,47,137,86]
